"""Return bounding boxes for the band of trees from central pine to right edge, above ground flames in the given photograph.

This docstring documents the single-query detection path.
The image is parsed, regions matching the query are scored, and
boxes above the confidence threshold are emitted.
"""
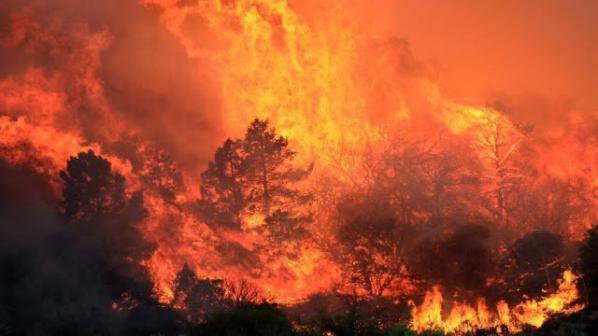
[198,117,596,304]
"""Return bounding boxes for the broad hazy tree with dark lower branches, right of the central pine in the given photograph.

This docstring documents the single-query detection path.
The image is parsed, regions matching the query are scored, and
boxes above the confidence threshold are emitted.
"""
[329,138,487,296]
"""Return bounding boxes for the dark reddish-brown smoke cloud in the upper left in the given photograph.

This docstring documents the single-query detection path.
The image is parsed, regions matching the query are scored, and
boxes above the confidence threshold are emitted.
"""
[0,0,221,170]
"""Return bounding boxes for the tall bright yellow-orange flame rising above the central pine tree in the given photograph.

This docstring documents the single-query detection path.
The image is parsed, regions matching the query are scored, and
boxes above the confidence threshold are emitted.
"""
[143,0,422,173]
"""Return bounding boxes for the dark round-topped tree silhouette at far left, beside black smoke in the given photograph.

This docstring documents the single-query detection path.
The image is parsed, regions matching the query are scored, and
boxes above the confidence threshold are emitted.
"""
[60,150,154,301]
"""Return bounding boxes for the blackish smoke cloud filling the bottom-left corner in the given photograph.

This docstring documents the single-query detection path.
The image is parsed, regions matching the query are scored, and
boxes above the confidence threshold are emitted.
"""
[0,160,182,335]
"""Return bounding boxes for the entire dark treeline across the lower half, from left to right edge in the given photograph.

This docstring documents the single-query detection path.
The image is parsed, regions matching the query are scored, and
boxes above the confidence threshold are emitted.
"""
[0,120,598,336]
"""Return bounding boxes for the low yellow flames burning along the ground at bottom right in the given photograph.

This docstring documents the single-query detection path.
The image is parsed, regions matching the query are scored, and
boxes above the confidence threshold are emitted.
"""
[411,270,583,334]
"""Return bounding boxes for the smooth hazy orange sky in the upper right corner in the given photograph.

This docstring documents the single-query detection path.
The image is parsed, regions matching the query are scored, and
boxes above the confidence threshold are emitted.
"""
[332,0,598,111]
